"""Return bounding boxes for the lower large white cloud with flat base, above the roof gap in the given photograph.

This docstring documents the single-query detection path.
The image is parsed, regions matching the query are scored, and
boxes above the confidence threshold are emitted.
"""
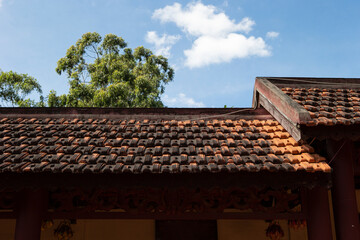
[184,33,270,68]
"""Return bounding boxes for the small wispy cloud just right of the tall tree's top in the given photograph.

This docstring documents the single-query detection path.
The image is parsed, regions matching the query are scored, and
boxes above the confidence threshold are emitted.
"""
[145,31,180,58]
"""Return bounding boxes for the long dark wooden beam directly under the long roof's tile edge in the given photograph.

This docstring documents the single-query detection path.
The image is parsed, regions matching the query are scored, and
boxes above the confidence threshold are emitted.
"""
[0,171,331,190]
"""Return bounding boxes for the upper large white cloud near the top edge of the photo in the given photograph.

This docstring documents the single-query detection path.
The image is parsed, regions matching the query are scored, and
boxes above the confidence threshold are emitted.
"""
[153,2,255,36]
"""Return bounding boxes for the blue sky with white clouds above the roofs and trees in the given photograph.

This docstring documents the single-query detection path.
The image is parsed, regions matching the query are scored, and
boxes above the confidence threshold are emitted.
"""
[0,0,360,107]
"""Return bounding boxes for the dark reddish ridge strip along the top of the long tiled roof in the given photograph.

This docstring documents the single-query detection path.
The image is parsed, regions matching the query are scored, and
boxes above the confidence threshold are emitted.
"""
[0,108,273,121]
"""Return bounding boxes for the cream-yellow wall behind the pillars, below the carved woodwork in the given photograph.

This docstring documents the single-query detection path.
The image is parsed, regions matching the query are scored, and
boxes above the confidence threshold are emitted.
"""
[0,220,307,240]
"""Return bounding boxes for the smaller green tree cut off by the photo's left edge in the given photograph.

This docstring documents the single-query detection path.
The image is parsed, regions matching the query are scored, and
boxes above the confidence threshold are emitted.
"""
[0,70,44,107]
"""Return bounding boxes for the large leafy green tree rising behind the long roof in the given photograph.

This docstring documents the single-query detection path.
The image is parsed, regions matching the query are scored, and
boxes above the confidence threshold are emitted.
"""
[48,33,174,107]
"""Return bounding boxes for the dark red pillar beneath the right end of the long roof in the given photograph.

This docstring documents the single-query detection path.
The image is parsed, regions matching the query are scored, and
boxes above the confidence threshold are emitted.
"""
[306,187,332,240]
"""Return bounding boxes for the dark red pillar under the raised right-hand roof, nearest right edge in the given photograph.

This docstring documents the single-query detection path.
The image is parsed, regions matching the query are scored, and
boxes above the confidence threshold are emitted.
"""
[327,140,360,240]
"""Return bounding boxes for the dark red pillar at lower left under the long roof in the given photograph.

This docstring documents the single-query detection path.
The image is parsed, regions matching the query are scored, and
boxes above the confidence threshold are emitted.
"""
[15,190,48,240]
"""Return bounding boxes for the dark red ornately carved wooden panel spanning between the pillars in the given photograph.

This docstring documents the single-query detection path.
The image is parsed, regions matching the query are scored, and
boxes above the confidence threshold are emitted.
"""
[49,188,301,215]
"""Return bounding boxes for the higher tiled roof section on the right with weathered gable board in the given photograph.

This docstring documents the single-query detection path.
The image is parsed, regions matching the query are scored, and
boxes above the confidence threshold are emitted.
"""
[254,77,360,140]
